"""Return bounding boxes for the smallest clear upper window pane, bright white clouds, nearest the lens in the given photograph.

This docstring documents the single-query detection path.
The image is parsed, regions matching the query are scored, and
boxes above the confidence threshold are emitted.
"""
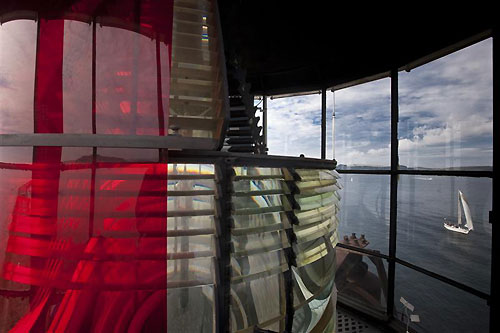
[267,94,321,158]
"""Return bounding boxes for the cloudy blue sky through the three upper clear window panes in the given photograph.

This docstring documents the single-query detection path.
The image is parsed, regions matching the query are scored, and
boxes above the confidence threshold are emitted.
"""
[268,39,493,168]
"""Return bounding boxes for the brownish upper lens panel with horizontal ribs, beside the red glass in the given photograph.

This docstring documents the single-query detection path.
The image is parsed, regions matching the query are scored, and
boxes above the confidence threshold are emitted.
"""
[169,0,226,138]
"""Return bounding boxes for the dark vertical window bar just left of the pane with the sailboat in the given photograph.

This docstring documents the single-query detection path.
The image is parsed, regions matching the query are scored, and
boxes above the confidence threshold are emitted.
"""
[387,69,399,317]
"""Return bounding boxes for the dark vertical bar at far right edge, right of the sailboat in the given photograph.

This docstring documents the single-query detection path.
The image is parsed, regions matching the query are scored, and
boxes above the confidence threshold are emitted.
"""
[490,27,500,332]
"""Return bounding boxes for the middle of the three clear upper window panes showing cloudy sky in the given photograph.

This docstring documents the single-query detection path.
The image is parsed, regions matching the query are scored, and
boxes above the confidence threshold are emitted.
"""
[334,79,391,169]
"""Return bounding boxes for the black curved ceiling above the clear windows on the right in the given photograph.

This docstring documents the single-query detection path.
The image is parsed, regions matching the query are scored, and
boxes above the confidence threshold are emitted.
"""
[218,0,493,95]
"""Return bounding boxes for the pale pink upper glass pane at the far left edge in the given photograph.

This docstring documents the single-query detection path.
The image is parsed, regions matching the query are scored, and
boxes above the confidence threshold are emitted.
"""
[0,20,37,134]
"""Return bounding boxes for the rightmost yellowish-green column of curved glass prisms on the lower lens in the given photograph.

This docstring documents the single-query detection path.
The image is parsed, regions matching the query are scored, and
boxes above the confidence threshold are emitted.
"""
[292,169,340,332]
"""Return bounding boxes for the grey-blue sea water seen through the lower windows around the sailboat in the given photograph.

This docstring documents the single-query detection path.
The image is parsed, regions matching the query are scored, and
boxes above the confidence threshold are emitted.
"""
[339,174,492,332]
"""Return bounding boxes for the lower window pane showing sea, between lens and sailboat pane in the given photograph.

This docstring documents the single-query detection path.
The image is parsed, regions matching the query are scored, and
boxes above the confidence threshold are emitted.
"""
[338,174,390,254]
